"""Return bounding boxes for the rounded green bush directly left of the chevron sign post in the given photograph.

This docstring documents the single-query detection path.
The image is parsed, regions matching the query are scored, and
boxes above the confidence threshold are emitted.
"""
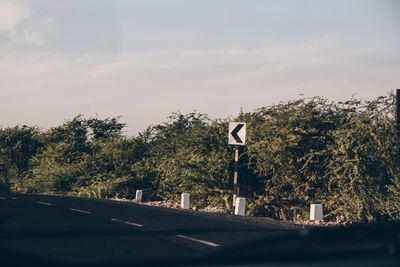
[131,113,231,207]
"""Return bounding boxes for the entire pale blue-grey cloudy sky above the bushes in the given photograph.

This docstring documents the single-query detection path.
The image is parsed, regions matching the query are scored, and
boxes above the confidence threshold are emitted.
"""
[0,0,400,136]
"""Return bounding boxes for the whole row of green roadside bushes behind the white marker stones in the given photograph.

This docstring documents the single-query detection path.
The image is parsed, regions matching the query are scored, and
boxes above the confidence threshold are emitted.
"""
[0,94,400,222]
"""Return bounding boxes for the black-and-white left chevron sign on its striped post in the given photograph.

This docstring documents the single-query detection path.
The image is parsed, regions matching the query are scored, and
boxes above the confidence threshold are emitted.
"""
[228,122,246,206]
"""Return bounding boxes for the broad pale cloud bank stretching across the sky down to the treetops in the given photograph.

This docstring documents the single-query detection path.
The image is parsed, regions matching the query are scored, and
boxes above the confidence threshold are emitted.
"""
[0,38,400,133]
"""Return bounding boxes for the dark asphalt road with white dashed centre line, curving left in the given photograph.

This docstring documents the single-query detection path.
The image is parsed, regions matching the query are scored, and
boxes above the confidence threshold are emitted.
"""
[0,195,295,265]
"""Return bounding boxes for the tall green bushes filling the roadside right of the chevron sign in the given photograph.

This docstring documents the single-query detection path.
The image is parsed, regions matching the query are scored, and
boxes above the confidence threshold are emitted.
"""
[244,96,400,222]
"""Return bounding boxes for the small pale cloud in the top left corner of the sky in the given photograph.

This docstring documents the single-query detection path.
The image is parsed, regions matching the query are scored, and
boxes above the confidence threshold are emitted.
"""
[0,1,30,32]
